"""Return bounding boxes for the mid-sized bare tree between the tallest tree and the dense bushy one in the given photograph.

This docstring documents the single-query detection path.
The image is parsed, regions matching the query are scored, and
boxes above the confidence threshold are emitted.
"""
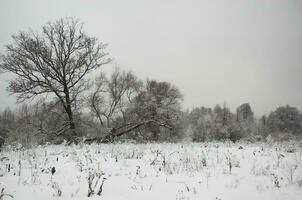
[88,68,141,129]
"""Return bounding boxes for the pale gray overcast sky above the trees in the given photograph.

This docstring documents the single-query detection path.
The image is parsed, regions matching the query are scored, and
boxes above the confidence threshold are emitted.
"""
[0,0,302,116]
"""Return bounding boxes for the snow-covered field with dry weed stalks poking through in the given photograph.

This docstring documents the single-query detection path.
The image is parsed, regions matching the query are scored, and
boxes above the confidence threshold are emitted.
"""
[0,143,302,200]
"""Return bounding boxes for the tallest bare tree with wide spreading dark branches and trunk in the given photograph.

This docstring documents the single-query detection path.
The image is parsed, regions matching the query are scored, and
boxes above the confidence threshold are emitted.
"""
[0,18,110,140]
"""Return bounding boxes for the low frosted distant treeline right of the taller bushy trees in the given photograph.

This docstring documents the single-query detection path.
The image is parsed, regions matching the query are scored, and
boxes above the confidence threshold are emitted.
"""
[180,103,302,142]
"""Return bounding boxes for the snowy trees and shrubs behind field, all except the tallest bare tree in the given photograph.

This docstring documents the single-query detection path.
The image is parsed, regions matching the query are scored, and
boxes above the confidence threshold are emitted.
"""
[0,68,302,145]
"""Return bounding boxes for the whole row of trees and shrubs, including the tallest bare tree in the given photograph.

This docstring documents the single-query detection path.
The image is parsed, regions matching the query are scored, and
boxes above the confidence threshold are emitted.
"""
[0,18,302,145]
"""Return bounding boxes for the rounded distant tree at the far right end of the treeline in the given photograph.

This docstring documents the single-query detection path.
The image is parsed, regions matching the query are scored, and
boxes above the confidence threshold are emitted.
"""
[267,105,302,135]
